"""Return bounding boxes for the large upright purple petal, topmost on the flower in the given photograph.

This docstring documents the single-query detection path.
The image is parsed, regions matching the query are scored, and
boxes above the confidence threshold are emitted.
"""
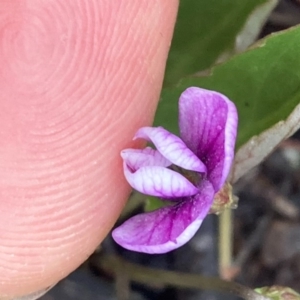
[179,87,238,191]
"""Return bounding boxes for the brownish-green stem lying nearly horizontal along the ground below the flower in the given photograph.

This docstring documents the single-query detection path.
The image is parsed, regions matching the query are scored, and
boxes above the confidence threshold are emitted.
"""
[96,255,270,300]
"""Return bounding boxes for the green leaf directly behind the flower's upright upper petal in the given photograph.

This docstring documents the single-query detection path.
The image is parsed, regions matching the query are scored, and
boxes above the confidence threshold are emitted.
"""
[155,27,300,148]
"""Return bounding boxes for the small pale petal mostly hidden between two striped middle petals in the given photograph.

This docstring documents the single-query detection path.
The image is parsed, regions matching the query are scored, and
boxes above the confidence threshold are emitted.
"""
[121,147,172,171]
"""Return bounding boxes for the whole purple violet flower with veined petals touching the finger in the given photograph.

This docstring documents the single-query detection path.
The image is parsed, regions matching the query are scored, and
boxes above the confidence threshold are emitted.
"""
[112,87,238,253]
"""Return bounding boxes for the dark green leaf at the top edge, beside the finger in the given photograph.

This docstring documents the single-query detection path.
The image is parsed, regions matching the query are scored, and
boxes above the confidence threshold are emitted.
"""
[165,0,270,86]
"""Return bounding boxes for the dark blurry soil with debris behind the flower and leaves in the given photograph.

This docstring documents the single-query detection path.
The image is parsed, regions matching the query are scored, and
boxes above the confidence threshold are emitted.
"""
[41,0,300,300]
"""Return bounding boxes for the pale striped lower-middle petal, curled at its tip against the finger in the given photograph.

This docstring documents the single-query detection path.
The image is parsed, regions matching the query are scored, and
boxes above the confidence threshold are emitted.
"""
[123,161,198,199]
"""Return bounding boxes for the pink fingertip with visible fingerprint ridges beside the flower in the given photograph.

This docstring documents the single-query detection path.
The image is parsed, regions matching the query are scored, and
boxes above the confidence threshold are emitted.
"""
[0,0,178,299]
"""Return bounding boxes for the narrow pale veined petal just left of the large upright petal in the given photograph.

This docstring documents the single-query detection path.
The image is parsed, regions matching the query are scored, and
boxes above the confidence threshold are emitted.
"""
[135,127,206,173]
